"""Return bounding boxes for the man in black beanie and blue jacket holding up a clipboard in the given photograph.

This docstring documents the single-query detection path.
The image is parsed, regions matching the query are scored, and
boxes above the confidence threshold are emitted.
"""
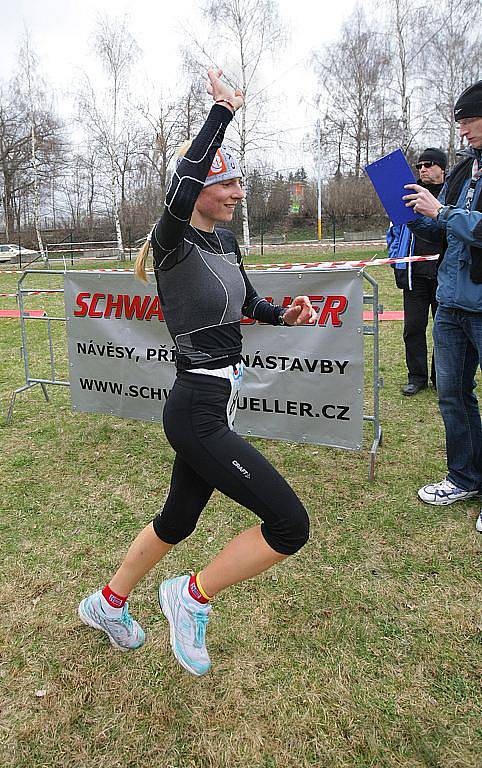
[366,80,482,533]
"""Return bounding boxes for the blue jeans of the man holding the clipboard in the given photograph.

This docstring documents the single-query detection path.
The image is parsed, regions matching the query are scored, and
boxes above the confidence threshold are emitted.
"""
[433,306,482,491]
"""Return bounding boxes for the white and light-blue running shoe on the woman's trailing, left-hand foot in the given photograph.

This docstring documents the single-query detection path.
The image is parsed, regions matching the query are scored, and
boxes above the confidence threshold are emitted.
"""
[78,592,146,651]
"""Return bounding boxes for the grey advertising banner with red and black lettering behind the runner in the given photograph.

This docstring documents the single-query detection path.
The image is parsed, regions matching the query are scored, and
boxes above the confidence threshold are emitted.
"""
[65,269,364,450]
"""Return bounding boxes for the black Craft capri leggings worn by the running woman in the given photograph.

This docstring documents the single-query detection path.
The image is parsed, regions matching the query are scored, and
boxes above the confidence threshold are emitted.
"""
[153,372,309,555]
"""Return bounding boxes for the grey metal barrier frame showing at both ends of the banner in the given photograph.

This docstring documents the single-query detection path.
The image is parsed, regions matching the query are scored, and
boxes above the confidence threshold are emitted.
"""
[7,269,383,480]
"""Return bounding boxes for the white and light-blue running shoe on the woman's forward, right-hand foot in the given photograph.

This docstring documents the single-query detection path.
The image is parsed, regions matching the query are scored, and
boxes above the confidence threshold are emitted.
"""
[159,576,211,675]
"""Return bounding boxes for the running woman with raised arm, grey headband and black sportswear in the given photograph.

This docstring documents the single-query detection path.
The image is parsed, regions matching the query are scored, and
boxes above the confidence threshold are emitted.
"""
[79,70,316,675]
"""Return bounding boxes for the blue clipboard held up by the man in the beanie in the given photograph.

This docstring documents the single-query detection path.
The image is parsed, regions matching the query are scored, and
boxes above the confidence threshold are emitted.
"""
[365,149,420,224]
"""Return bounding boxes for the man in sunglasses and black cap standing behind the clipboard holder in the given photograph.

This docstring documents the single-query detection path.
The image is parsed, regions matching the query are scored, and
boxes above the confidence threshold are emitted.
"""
[387,147,447,396]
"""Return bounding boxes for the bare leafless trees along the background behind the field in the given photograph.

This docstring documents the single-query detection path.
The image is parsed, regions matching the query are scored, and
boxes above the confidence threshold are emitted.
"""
[0,0,482,253]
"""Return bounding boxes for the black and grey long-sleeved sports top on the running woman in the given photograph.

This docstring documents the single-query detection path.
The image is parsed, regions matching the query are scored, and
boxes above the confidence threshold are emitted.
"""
[152,104,283,370]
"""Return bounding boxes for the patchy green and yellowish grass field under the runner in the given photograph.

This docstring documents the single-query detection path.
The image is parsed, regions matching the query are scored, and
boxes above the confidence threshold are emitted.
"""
[0,254,482,768]
